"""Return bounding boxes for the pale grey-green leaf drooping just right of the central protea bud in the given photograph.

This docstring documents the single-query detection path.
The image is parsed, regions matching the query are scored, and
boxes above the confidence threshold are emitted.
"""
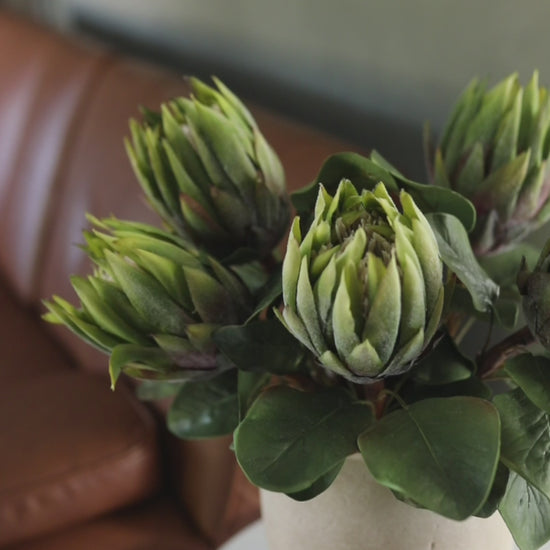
[426,213,499,311]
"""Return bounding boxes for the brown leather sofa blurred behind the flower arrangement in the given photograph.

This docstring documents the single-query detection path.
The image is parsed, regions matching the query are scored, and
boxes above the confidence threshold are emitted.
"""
[0,11,356,550]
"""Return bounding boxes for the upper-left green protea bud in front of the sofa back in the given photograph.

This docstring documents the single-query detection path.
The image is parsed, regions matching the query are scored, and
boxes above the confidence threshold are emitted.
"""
[126,79,290,256]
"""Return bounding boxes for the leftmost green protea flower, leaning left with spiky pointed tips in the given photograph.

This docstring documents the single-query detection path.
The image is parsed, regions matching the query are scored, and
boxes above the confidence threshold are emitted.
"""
[45,218,251,384]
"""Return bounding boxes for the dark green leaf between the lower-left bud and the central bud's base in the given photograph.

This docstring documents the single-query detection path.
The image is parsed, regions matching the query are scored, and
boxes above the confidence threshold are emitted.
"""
[213,319,304,374]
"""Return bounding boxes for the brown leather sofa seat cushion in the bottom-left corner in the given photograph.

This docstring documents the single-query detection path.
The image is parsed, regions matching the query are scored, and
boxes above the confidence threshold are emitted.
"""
[0,370,160,546]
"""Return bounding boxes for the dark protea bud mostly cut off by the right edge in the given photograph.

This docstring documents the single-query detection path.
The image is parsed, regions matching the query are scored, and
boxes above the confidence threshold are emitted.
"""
[518,240,550,349]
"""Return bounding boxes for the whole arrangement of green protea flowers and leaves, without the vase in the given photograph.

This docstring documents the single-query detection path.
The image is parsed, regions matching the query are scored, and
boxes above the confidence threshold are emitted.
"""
[45,73,550,550]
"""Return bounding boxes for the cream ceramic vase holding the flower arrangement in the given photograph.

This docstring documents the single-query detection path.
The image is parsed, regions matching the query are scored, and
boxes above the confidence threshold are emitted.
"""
[260,455,514,550]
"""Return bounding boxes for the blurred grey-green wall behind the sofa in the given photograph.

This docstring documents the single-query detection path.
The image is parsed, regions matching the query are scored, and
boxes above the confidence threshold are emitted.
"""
[3,0,550,174]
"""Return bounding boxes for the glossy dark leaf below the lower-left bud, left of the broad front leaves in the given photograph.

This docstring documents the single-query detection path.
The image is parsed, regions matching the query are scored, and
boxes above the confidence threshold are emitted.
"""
[167,370,239,439]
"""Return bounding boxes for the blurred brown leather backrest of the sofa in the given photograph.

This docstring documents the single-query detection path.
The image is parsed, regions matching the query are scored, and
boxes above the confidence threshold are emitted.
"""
[0,11,354,371]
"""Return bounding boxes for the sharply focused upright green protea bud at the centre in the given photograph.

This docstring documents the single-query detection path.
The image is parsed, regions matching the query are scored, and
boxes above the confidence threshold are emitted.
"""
[282,180,443,382]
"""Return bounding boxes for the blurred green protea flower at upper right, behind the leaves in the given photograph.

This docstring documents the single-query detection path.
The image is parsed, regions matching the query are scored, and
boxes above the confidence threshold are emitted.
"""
[431,72,550,255]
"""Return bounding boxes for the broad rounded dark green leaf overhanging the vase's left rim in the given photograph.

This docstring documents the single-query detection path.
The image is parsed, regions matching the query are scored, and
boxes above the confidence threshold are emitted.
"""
[235,386,372,493]
